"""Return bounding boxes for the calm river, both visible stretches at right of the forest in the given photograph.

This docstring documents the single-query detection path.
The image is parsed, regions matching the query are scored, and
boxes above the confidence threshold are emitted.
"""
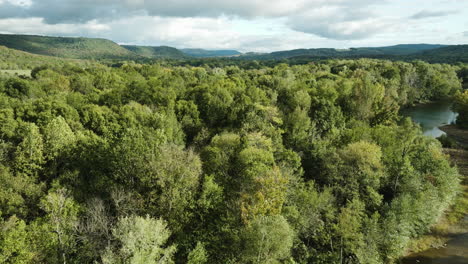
[401,101,468,264]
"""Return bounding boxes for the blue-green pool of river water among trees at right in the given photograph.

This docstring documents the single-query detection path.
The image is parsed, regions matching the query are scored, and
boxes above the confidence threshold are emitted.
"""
[401,101,458,137]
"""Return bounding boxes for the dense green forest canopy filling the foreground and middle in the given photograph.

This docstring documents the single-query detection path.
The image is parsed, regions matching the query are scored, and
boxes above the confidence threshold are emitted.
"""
[0,59,461,264]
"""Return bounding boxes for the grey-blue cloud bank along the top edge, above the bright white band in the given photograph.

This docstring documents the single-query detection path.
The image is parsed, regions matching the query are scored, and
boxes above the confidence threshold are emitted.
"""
[0,0,375,24]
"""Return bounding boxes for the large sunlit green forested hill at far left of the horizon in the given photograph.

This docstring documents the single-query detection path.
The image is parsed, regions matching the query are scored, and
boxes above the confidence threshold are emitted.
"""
[0,34,137,59]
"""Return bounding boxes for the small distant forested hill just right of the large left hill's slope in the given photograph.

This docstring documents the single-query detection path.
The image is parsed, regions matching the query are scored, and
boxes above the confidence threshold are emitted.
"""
[122,45,190,59]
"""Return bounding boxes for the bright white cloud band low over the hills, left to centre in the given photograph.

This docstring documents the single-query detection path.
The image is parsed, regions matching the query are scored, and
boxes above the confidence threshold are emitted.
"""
[0,16,336,52]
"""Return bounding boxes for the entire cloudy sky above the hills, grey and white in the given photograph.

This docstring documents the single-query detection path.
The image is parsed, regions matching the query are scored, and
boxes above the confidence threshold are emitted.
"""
[0,0,468,52]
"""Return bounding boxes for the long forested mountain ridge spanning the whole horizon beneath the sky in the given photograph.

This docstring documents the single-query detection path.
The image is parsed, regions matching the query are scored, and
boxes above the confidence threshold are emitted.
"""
[0,34,468,63]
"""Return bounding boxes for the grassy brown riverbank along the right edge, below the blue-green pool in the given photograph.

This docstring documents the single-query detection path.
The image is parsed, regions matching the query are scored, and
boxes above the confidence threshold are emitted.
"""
[401,125,468,264]
